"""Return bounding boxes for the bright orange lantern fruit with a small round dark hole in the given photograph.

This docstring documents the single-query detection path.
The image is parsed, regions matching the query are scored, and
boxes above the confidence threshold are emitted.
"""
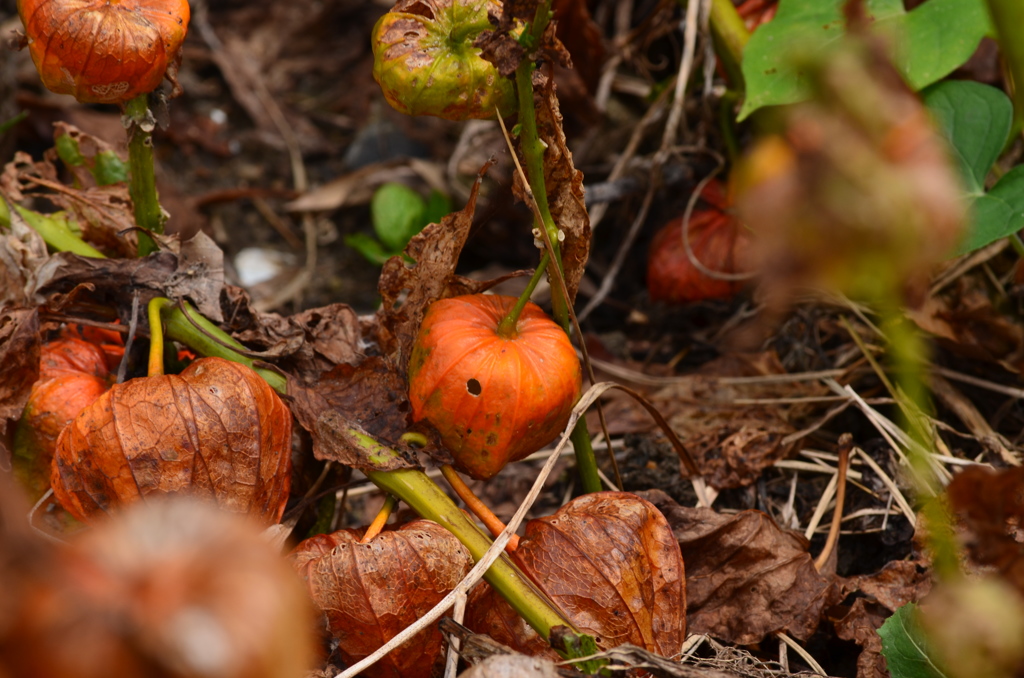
[409,294,582,479]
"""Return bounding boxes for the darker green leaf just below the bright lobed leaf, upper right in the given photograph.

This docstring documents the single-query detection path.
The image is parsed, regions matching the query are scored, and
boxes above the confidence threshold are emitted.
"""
[924,80,1014,196]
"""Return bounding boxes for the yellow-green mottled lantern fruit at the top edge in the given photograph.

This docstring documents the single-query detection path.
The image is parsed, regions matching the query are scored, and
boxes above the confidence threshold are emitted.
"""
[371,0,515,120]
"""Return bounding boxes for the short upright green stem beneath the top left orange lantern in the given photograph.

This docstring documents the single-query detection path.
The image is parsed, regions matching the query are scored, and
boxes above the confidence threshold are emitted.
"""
[125,94,166,256]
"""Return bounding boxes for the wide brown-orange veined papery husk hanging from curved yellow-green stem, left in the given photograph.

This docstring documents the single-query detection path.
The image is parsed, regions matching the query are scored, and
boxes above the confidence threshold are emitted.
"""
[50,357,292,524]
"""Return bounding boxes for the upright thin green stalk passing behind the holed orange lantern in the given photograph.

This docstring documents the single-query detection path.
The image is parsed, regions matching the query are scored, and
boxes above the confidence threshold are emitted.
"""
[515,6,601,493]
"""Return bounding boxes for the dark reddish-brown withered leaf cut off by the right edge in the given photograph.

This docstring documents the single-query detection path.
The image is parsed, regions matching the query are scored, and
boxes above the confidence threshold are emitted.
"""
[946,466,1024,592]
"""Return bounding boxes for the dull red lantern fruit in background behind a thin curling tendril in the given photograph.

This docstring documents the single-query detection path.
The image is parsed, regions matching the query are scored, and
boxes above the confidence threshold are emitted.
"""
[647,181,750,304]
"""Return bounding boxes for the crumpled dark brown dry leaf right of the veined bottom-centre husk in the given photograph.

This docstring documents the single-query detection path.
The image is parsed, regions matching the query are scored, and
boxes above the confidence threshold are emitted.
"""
[639,490,840,645]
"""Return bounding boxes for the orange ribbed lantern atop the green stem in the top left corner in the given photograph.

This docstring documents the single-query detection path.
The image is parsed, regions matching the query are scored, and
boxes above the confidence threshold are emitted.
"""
[17,0,189,103]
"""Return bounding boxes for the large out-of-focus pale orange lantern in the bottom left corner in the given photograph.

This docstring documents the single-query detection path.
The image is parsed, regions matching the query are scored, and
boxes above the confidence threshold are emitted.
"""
[0,498,314,678]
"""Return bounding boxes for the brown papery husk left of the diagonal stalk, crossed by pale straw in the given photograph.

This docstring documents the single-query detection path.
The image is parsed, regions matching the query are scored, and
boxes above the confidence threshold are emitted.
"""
[292,520,473,678]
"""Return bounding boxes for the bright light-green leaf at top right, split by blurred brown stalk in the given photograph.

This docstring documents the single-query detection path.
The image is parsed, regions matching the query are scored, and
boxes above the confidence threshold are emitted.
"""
[739,0,990,120]
